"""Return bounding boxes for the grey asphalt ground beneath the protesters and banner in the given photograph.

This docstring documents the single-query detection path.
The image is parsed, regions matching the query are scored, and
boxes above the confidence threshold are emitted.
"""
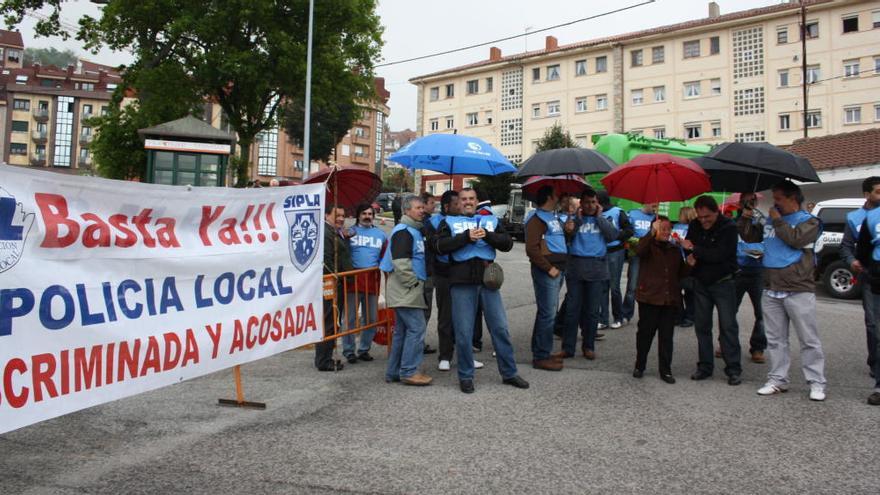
[0,237,880,494]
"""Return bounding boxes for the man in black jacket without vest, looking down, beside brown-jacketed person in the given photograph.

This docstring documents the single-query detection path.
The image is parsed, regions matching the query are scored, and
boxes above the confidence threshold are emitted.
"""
[681,196,742,385]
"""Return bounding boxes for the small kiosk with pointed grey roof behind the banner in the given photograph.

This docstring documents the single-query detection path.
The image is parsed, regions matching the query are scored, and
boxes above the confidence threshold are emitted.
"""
[138,115,235,186]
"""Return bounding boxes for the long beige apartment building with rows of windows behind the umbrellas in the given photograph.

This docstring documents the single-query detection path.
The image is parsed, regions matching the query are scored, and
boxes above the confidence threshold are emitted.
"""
[410,0,880,194]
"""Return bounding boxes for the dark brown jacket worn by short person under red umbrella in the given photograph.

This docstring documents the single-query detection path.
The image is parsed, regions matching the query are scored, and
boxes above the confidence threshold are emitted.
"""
[636,232,690,307]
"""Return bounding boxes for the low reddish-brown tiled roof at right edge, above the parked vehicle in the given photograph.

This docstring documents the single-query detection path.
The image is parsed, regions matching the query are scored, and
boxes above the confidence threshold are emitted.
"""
[784,128,880,170]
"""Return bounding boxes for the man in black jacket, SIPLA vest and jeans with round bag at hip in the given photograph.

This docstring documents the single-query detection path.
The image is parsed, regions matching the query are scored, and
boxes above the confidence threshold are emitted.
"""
[437,188,529,394]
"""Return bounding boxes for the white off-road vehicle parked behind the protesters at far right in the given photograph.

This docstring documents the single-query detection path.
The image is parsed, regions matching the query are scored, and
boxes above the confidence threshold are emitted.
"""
[811,198,865,299]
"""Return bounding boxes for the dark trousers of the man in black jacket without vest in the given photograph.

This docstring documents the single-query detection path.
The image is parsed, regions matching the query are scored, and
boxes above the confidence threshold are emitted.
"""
[694,279,742,376]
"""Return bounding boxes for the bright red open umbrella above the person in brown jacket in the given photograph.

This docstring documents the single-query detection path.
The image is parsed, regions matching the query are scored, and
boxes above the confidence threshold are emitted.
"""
[602,153,711,203]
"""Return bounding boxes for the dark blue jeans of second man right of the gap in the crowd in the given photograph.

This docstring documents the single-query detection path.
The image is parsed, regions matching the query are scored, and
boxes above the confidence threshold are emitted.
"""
[562,277,606,356]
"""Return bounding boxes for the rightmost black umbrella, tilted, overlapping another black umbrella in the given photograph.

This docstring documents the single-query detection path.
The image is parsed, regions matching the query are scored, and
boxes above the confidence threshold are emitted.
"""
[706,143,822,182]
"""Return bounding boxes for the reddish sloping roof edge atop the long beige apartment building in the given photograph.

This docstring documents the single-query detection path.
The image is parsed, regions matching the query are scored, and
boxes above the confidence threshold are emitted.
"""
[409,0,834,82]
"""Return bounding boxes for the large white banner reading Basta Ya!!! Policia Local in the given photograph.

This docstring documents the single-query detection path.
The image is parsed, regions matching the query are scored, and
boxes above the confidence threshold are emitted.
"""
[0,165,324,433]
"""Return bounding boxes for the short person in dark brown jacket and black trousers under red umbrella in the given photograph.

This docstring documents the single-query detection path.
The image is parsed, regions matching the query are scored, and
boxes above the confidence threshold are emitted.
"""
[633,216,689,383]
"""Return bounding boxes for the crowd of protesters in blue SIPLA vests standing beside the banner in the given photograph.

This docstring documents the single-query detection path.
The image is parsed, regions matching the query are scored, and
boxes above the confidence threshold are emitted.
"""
[315,177,880,405]
